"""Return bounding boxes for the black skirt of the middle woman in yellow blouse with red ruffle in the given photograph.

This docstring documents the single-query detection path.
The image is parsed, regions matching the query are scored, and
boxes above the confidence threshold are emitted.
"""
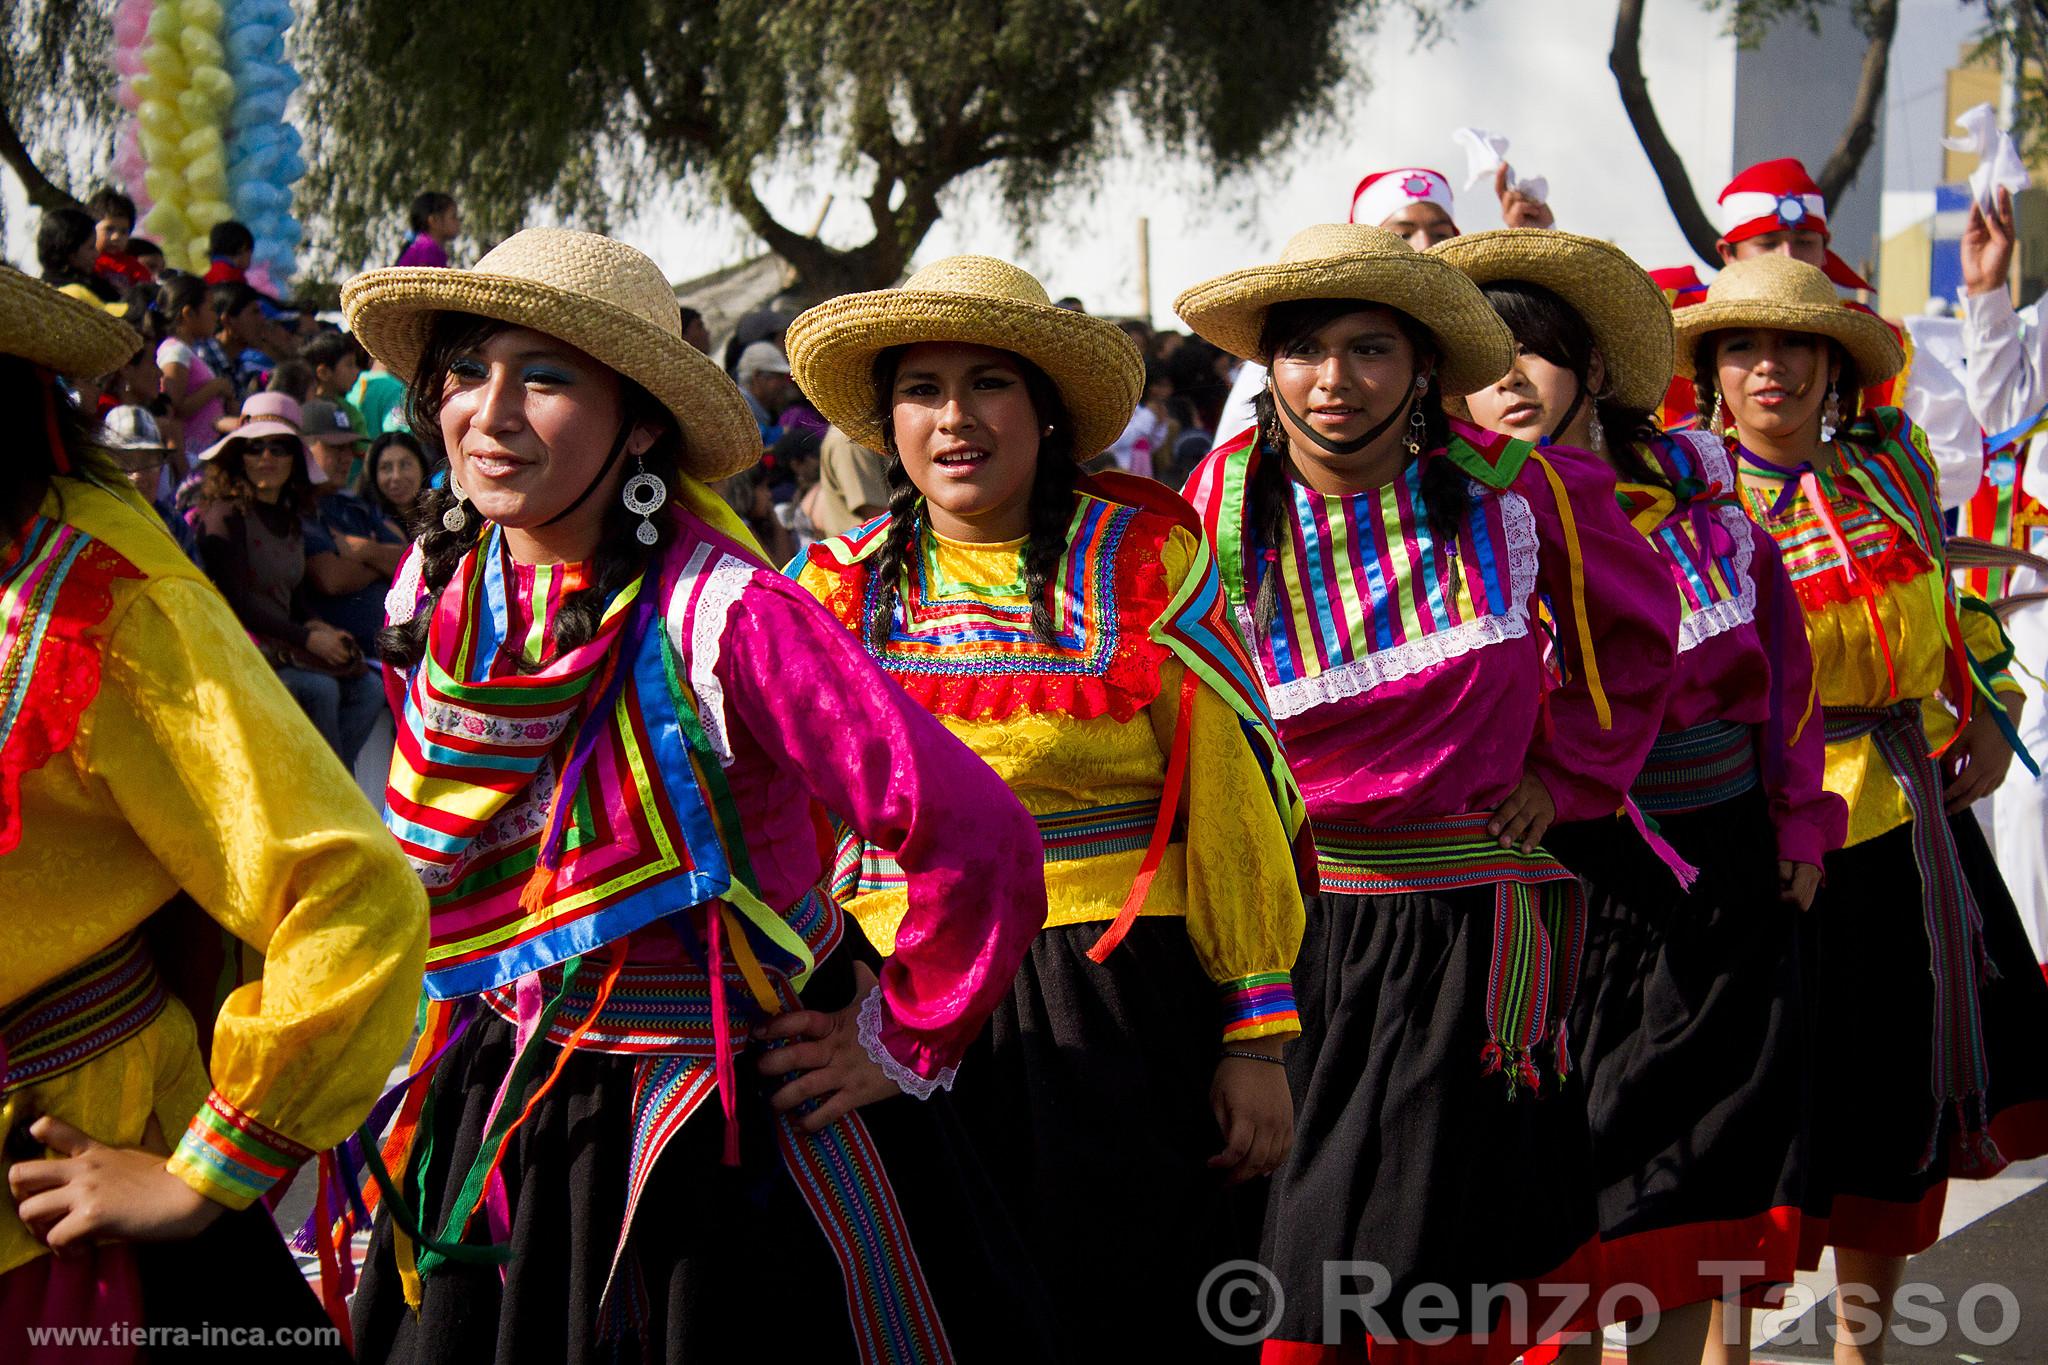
[952,917,1266,1361]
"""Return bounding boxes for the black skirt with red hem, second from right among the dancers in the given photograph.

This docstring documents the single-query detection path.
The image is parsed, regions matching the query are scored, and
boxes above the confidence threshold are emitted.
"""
[1546,788,1810,1312]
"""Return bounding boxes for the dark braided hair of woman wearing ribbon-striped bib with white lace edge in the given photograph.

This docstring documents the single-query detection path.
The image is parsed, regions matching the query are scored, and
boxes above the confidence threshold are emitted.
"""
[1245,299,1470,632]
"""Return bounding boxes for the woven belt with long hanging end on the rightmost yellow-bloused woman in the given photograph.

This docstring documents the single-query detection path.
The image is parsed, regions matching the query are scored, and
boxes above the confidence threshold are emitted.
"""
[1825,702,1999,1171]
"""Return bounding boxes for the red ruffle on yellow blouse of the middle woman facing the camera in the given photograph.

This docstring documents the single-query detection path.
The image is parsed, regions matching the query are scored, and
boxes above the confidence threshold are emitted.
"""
[811,512,1174,722]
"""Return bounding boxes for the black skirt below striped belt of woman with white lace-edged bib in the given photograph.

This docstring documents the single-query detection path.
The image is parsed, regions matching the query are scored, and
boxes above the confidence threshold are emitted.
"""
[1262,886,1595,1361]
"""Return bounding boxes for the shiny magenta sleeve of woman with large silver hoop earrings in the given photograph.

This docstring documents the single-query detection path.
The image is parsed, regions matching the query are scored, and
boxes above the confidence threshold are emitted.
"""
[717,571,1044,1081]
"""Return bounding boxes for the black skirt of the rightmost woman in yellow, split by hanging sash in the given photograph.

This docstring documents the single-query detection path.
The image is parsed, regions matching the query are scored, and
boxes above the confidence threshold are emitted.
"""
[1804,812,2048,1265]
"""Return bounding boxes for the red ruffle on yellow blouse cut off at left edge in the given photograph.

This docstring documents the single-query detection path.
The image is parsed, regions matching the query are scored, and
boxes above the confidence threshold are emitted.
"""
[0,540,141,853]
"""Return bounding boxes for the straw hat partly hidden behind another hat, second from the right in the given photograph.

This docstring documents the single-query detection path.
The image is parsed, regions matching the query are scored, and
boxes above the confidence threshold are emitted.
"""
[1430,227,1671,411]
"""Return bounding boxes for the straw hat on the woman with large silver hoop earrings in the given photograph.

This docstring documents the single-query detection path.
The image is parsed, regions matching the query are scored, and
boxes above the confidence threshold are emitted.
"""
[342,227,762,481]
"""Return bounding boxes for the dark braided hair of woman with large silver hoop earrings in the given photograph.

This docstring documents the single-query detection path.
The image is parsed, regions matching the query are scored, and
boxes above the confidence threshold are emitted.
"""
[377,313,682,669]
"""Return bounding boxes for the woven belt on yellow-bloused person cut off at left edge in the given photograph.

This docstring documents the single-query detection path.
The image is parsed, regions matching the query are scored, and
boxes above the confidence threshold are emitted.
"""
[0,933,170,1095]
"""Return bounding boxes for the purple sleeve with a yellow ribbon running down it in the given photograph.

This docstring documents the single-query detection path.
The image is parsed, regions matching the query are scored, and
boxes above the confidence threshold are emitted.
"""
[1513,448,1679,821]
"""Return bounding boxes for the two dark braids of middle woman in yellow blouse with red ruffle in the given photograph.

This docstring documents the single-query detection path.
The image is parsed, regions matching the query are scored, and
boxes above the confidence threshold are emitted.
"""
[864,346,1081,653]
